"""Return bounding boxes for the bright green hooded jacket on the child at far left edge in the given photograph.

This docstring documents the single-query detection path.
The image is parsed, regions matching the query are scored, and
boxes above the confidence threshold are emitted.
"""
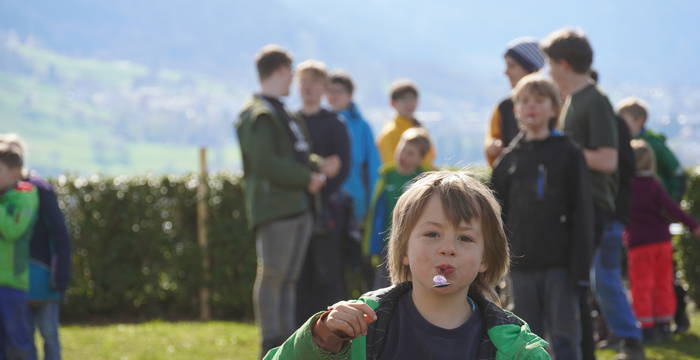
[0,182,39,290]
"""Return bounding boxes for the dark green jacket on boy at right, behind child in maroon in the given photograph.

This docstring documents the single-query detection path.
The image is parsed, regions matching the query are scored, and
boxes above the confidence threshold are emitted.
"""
[639,129,686,202]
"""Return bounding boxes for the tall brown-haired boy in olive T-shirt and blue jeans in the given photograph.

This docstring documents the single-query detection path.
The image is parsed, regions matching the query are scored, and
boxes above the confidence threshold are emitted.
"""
[541,29,644,359]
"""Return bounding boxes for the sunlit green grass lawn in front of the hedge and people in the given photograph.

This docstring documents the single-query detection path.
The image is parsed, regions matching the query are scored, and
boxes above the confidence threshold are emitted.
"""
[61,312,700,360]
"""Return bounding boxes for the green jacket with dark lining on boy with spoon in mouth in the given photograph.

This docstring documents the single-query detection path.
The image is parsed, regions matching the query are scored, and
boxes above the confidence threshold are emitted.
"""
[264,282,550,360]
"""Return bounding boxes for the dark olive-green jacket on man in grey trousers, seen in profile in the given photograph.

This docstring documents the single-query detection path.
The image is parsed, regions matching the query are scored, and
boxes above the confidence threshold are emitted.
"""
[235,95,318,228]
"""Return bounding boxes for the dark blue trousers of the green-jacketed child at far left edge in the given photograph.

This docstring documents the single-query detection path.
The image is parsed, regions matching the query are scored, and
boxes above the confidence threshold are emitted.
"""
[0,286,36,360]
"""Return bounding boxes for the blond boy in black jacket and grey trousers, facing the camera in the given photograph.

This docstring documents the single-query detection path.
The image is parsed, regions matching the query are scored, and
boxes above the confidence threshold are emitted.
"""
[492,75,593,359]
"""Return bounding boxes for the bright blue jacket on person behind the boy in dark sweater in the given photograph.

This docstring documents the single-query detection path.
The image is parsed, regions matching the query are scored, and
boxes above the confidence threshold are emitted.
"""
[338,103,382,223]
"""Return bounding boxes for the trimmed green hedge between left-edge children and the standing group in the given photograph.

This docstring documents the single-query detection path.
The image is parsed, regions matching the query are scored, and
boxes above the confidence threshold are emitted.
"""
[54,174,255,321]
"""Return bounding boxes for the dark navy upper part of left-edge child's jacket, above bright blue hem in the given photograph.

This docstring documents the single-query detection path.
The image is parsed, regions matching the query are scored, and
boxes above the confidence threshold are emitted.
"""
[28,176,71,292]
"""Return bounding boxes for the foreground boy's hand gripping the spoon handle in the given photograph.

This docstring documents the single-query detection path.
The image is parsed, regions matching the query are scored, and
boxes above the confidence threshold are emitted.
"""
[324,301,377,341]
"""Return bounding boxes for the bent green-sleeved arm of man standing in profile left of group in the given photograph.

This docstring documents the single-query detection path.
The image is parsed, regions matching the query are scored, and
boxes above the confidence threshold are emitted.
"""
[250,115,311,189]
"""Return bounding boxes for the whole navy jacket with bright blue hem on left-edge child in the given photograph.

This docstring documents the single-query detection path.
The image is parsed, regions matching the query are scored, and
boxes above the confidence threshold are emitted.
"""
[28,176,71,301]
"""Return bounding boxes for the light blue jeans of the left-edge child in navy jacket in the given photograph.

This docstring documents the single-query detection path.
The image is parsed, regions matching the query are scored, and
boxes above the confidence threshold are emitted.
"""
[29,301,61,360]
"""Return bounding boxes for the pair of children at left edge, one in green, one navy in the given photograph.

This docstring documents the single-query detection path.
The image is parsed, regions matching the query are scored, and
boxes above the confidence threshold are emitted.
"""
[0,134,70,360]
